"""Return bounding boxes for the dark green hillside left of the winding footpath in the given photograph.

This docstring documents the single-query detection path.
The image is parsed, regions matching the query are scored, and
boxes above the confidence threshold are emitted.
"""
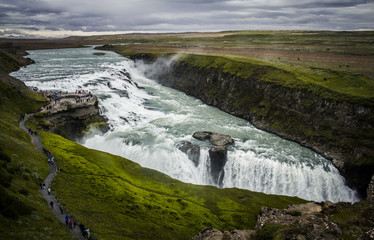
[0,72,73,240]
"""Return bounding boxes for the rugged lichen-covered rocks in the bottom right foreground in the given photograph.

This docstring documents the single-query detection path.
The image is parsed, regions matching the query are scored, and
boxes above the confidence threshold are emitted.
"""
[192,202,374,240]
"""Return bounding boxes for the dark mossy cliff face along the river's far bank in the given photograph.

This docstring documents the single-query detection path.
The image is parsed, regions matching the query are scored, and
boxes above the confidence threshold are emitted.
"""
[135,54,374,196]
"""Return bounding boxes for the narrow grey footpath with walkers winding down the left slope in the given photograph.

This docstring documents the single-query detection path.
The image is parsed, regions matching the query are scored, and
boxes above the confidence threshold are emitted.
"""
[19,114,86,240]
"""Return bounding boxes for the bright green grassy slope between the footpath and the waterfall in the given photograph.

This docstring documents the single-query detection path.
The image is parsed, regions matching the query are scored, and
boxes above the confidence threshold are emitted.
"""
[41,133,304,239]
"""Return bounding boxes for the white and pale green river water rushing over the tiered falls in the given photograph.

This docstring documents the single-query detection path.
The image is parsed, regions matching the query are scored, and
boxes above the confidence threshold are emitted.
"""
[11,47,359,202]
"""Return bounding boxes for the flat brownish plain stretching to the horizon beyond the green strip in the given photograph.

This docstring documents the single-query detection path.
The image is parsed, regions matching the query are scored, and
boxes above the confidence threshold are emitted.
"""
[84,31,374,78]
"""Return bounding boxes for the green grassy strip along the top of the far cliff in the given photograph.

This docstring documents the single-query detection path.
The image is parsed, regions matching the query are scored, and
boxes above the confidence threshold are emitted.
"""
[180,54,374,105]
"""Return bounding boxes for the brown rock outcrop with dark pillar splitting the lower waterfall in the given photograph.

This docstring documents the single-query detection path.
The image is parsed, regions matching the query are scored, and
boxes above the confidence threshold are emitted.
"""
[193,132,234,186]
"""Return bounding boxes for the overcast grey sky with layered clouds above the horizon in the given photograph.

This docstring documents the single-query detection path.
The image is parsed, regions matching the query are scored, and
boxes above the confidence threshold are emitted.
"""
[0,0,374,37]
